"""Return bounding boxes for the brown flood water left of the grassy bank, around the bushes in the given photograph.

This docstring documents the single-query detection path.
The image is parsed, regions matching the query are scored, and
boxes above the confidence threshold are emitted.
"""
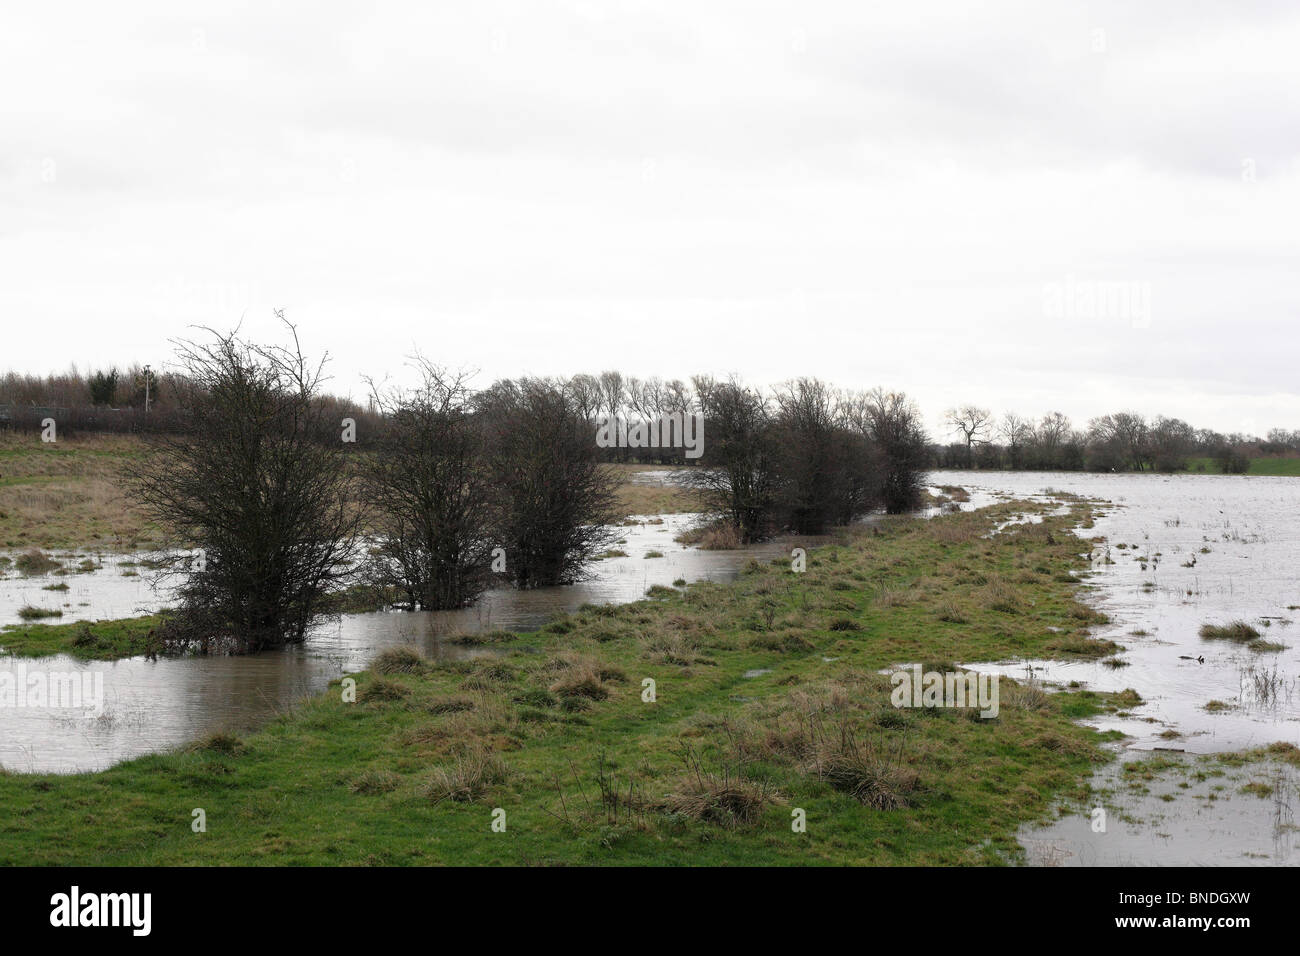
[0,512,811,773]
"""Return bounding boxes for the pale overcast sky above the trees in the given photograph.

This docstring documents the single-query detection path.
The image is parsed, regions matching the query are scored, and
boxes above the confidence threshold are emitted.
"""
[0,0,1300,434]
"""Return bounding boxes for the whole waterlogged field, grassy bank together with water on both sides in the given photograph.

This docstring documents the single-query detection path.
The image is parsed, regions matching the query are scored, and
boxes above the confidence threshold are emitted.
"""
[0,470,1300,865]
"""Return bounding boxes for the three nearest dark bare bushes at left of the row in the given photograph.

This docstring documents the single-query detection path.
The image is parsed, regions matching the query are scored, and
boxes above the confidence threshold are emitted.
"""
[133,323,616,653]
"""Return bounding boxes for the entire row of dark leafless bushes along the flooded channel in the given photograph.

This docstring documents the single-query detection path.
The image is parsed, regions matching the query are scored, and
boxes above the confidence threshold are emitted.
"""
[119,325,927,653]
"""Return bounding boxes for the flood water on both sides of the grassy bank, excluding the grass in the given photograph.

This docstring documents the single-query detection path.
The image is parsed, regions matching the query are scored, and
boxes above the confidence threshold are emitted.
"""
[0,471,1300,865]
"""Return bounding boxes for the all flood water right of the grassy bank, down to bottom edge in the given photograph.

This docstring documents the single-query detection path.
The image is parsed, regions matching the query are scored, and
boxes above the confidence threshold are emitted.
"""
[932,472,1300,866]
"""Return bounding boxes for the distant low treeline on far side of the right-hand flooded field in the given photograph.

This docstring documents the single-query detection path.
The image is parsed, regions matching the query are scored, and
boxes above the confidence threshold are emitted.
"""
[931,405,1279,473]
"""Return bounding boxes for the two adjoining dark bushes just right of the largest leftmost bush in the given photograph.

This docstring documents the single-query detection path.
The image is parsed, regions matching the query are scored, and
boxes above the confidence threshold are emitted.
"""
[360,356,616,610]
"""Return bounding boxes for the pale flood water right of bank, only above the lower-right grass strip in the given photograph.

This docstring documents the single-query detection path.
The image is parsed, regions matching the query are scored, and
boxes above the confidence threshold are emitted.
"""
[944,472,1300,753]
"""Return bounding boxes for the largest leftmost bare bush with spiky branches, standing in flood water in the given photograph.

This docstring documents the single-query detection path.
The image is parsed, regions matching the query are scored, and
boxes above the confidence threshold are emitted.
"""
[134,321,360,653]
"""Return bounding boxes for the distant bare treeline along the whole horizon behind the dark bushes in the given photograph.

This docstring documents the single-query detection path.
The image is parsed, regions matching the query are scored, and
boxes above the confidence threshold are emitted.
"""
[0,364,1300,473]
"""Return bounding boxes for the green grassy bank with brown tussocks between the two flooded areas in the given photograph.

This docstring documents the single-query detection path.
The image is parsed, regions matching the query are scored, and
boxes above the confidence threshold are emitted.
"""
[0,503,1136,865]
